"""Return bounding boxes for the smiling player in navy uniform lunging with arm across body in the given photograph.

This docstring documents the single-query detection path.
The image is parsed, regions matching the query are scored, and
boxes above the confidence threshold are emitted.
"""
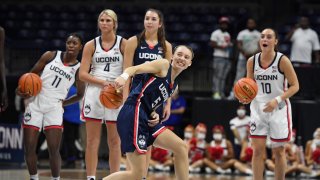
[104,45,193,180]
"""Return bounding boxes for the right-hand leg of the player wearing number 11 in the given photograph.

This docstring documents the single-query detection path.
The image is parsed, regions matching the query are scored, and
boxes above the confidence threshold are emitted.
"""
[45,128,62,177]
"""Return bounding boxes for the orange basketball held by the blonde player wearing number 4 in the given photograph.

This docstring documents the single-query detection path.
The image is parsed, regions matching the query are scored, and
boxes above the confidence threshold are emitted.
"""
[100,86,123,109]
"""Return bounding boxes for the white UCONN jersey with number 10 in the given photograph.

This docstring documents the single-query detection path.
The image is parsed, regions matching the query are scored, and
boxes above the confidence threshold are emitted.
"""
[253,52,288,102]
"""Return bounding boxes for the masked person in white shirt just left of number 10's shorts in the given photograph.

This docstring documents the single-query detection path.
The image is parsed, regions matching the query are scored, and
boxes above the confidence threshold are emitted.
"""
[230,105,250,159]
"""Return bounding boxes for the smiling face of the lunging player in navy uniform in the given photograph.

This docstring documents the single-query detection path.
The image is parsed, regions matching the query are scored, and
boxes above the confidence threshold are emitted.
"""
[172,46,193,70]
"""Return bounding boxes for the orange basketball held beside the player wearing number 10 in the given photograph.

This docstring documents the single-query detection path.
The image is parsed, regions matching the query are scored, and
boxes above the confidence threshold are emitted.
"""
[233,78,258,103]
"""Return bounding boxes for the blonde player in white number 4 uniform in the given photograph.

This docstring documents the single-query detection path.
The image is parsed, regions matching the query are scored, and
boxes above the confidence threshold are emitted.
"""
[79,9,126,180]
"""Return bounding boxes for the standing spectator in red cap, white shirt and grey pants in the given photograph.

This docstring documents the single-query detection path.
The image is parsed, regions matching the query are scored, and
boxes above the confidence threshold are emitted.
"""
[210,17,232,99]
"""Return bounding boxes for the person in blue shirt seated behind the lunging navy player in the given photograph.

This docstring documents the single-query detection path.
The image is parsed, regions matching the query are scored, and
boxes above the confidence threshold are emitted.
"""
[162,88,187,137]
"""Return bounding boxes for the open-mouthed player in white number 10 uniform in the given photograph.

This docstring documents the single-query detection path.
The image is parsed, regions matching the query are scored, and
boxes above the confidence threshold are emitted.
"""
[244,28,299,180]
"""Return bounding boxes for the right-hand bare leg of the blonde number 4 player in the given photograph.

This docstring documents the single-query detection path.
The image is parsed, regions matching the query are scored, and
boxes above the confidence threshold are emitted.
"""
[106,123,121,173]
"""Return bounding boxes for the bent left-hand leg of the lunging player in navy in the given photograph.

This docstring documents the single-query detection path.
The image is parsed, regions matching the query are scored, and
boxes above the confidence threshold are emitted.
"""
[103,151,146,180]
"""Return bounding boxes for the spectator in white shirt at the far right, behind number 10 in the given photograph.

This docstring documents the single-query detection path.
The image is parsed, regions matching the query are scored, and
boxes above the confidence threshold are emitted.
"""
[286,17,320,64]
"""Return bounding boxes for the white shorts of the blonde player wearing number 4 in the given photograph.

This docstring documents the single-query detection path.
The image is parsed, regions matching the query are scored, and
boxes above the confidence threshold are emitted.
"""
[81,84,122,123]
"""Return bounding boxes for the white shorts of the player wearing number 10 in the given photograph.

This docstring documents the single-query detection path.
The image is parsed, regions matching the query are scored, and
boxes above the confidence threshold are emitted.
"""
[250,100,292,142]
